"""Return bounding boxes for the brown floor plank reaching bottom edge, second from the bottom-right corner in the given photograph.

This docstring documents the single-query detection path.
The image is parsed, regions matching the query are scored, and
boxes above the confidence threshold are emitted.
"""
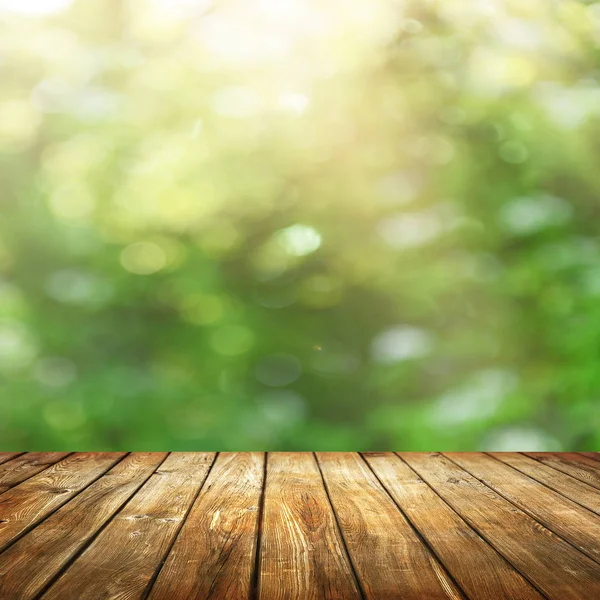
[364,452,544,600]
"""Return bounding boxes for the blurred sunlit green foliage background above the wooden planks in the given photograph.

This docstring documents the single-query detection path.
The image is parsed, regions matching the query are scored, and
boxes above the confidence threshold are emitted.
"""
[0,0,600,450]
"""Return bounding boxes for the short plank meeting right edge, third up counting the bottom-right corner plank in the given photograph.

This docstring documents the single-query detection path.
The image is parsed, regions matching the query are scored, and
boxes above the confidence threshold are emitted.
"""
[490,452,600,515]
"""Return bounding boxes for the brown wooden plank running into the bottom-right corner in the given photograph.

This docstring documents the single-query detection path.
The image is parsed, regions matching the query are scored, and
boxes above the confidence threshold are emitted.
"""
[399,452,600,600]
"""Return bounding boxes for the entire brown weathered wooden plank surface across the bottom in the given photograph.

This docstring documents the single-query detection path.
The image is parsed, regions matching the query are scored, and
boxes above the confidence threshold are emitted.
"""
[0,452,600,600]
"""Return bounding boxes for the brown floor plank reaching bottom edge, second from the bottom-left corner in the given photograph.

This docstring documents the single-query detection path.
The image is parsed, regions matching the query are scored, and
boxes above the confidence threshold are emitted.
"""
[42,452,214,600]
